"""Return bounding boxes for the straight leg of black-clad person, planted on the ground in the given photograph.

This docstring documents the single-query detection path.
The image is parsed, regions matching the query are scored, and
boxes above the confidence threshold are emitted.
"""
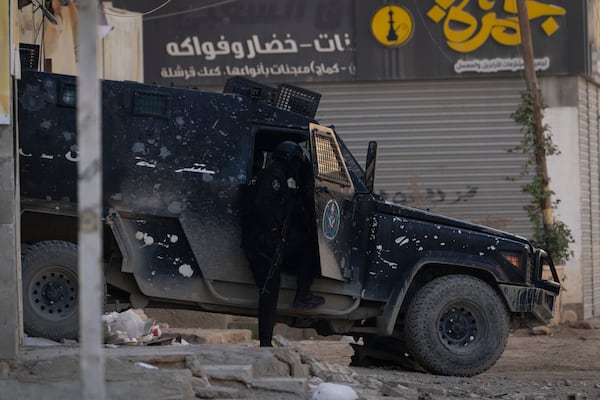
[250,259,281,347]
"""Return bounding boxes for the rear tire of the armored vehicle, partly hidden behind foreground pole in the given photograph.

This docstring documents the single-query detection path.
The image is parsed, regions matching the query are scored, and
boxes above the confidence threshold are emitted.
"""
[22,240,79,341]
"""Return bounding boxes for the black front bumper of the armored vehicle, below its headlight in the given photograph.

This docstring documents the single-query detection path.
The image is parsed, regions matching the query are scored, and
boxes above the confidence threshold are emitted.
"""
[498,284,557,325]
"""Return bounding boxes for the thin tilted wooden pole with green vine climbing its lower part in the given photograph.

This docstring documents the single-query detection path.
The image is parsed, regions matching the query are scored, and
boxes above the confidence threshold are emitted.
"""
[517,0,554,231]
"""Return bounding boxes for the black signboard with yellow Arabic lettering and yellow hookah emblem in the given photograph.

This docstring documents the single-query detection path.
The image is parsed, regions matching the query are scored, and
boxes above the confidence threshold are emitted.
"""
[355,0,588,79]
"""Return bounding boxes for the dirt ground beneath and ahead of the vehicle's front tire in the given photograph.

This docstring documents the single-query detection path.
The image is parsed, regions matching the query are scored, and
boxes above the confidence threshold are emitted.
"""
[294,324,600,400]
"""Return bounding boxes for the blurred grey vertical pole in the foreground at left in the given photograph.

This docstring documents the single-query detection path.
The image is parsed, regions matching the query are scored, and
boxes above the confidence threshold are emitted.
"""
[77,0,105,400]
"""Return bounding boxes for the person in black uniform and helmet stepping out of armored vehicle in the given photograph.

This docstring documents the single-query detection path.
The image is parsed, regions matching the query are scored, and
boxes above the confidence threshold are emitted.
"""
[242,141,325,347]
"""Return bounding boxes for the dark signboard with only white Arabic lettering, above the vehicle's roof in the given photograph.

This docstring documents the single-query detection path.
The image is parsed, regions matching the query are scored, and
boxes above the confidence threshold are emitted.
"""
[113,0,356,87]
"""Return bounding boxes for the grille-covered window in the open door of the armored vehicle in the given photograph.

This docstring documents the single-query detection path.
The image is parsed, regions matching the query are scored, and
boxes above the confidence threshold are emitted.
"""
[314,131,351,186]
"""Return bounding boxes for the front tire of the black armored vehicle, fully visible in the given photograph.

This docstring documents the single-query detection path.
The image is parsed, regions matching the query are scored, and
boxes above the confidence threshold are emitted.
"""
[404,275,509,376]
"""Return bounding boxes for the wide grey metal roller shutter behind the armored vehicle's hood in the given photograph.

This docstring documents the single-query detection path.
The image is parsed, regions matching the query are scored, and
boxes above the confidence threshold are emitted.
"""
[302,79,531,236]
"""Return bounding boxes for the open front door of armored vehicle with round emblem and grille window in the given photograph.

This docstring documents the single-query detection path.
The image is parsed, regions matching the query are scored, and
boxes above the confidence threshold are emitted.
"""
[309,124,355,280]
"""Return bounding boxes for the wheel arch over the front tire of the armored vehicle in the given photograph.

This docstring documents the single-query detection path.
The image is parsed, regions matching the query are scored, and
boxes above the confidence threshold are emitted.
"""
[377,259,509,336]
